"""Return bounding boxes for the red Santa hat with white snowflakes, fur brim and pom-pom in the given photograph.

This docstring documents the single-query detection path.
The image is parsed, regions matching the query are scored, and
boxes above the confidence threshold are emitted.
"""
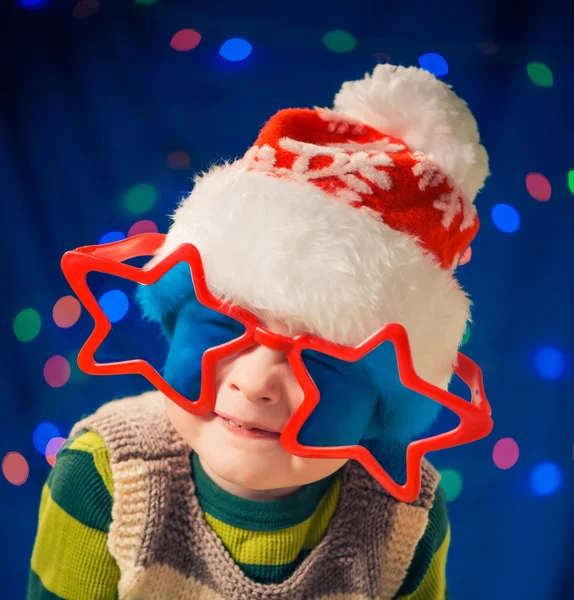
[138,64,488,389]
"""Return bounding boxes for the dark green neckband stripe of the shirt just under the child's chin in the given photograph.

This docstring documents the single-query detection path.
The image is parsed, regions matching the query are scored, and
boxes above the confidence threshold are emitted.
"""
[190,452,337,531]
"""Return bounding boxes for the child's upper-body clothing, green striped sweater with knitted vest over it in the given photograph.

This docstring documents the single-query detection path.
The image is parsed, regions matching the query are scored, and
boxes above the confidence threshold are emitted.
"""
[28,391,450,600]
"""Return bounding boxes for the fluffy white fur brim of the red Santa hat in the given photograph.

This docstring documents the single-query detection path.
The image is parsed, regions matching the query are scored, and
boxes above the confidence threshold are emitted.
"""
[150,160,471,389]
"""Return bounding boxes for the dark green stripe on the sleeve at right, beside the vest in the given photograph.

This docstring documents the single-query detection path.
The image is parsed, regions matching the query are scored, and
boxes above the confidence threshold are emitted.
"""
[397,485,448,596]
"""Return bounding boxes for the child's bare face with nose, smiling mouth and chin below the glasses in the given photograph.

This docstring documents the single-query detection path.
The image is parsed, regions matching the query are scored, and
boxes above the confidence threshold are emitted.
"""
[166,321,348,500]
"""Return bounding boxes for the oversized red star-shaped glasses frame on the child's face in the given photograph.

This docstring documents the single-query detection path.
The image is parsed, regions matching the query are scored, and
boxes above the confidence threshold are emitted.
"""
[61,233,493,502]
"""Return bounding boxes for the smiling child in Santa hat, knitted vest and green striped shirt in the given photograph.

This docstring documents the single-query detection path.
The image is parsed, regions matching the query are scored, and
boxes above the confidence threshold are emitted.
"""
[29,65,488,600]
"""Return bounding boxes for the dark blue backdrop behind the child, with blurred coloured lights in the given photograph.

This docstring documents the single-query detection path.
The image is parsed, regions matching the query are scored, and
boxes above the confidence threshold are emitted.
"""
[0,0,574,600]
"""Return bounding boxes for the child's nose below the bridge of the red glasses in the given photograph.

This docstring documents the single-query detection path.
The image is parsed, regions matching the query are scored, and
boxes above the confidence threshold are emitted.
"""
[227,344,294,406]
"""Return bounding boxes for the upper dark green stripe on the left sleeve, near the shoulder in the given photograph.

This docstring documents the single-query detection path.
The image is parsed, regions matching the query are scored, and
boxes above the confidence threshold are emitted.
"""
[47,440,113,533]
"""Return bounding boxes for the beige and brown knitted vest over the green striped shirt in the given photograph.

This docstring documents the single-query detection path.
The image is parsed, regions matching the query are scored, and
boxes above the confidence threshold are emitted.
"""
[70,391,440,600]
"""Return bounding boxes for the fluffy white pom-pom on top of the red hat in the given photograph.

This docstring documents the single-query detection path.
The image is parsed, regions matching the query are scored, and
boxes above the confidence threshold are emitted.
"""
[333,64,489,202]
